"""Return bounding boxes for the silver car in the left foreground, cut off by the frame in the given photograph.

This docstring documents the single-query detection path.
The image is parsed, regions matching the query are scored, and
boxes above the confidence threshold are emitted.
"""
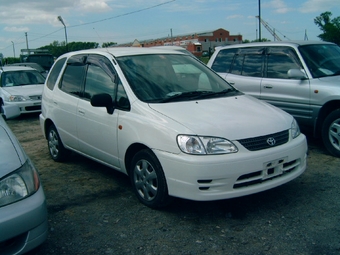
[0,105,47,255]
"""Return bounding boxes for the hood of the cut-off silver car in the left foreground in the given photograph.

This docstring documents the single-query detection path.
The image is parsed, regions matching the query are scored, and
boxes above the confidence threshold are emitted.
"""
[0,124,22,178]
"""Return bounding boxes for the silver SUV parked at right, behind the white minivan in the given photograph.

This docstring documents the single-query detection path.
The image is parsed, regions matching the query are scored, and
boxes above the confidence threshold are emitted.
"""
[207,41,340,157]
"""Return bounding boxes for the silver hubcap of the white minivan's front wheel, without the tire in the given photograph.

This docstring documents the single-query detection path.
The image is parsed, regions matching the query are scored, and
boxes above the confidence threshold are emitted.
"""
[134,160,158,201]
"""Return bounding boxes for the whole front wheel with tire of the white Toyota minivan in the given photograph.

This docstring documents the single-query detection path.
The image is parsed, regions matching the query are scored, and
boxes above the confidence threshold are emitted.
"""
[129,149,171,208]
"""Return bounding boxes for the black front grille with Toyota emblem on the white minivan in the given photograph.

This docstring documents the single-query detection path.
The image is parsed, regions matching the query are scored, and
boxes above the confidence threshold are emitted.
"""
[238,130,289,151]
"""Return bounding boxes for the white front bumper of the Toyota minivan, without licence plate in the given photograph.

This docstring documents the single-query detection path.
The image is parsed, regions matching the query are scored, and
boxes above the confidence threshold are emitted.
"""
[154,134,307,201]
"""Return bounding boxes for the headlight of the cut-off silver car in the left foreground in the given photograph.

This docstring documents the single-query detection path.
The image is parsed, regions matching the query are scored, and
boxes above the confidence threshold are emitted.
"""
[0,160,40,207]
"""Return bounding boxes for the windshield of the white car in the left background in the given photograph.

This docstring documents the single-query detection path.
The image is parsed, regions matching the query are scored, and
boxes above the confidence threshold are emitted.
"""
[1,70,45,87]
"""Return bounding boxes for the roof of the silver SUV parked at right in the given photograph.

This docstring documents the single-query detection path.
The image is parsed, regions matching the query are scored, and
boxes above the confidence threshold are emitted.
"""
[216,40,335,49]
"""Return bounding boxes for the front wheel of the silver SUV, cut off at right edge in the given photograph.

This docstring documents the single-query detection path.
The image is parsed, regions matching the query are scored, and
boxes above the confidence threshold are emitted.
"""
[322,109,340,157]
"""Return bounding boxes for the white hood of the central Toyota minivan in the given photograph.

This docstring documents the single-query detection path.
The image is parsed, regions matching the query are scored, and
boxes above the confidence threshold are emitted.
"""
[150,95,293,140]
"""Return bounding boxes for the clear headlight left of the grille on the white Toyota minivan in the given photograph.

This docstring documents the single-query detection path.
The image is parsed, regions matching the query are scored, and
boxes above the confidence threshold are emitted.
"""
[177,135,238,155]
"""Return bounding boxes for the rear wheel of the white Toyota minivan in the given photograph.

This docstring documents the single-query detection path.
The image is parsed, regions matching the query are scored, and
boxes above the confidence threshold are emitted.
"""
[47,125,67,162]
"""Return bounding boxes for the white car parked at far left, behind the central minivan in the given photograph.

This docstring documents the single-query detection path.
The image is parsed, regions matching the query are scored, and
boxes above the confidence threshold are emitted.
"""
[0,66,45,117]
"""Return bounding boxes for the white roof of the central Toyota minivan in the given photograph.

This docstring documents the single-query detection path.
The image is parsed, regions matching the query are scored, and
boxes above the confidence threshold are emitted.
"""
[59,47,185,58]
